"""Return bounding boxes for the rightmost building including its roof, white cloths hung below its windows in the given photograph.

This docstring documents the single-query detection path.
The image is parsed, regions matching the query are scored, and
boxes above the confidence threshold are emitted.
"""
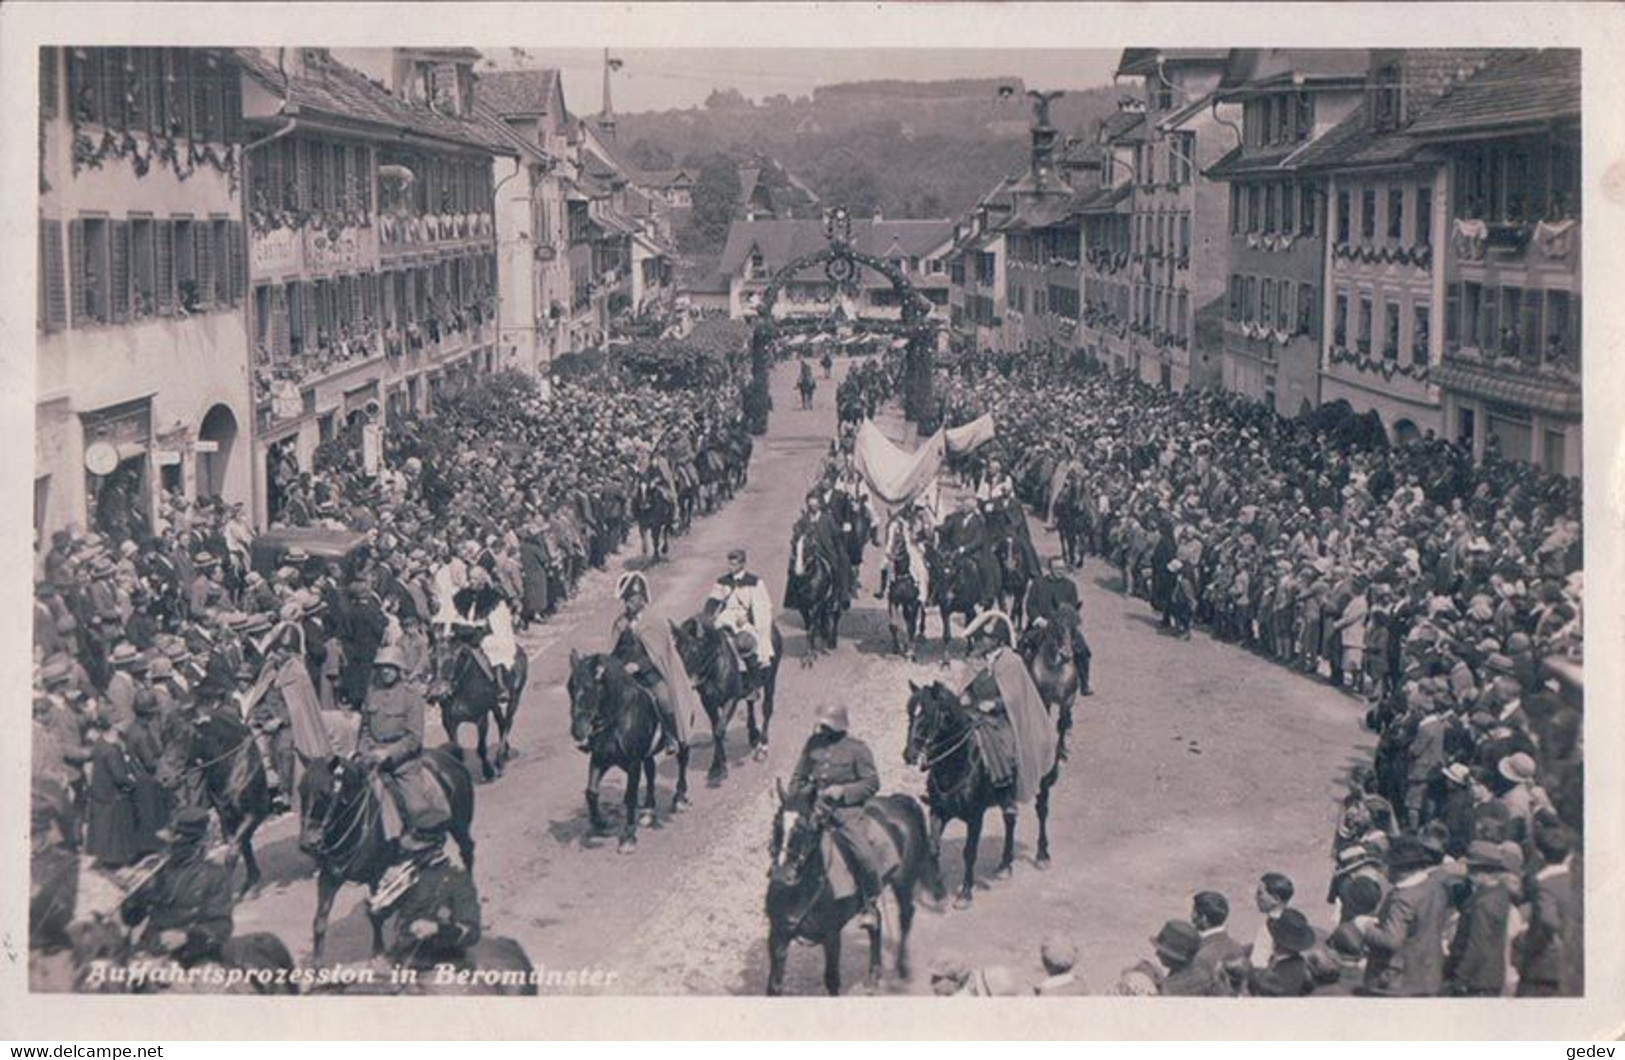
[1411,49,1581,475]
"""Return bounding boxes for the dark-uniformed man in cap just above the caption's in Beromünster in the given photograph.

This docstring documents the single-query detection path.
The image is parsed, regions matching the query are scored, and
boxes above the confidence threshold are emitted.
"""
[369,829,479,971]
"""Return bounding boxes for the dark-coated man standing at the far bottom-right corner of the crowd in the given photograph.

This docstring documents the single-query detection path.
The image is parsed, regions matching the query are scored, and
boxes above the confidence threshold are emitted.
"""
[1518,821,1586,997]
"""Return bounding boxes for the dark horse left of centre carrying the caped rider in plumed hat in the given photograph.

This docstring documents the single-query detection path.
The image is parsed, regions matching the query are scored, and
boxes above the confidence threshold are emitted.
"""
[566,649,689,854]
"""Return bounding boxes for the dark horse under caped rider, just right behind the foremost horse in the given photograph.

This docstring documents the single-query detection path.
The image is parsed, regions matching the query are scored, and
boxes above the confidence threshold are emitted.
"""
[904,681,1060,909]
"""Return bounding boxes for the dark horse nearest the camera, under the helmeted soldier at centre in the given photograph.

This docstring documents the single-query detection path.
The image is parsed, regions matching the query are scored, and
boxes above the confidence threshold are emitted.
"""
[767,782,946,997]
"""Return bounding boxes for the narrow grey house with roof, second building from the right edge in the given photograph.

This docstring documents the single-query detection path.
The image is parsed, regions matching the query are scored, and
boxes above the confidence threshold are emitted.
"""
[1207,49,1368,416]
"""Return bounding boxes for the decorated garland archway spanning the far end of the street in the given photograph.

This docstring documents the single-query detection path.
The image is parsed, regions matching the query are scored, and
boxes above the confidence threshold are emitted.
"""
[751,206,936,429]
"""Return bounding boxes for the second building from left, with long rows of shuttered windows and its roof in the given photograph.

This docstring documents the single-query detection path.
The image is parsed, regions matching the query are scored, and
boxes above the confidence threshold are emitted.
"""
[239,49,515,522]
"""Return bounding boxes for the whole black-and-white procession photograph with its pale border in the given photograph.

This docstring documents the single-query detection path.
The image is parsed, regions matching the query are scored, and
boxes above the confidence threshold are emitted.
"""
[7,5,1625,1034]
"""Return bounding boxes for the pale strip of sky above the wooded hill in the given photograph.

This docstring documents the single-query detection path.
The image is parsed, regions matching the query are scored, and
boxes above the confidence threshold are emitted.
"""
[484,47,1120,114]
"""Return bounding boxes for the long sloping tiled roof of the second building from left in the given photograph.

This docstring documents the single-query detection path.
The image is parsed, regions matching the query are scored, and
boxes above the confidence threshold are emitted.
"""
[236,47,517,154]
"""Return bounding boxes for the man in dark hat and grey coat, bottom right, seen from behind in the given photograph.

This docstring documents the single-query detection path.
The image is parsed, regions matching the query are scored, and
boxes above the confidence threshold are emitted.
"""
[1355,836,1450,997]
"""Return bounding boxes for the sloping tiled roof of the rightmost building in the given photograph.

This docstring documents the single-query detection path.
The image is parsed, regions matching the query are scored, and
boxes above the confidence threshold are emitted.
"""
[1409,49,1580,138]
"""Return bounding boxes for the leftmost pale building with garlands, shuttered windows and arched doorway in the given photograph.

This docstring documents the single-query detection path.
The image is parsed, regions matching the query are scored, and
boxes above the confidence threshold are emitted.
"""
[34,47,254,537]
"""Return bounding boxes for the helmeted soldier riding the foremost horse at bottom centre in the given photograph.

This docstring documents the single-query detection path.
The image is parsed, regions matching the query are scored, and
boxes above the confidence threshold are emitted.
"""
[787,702,895,927]
